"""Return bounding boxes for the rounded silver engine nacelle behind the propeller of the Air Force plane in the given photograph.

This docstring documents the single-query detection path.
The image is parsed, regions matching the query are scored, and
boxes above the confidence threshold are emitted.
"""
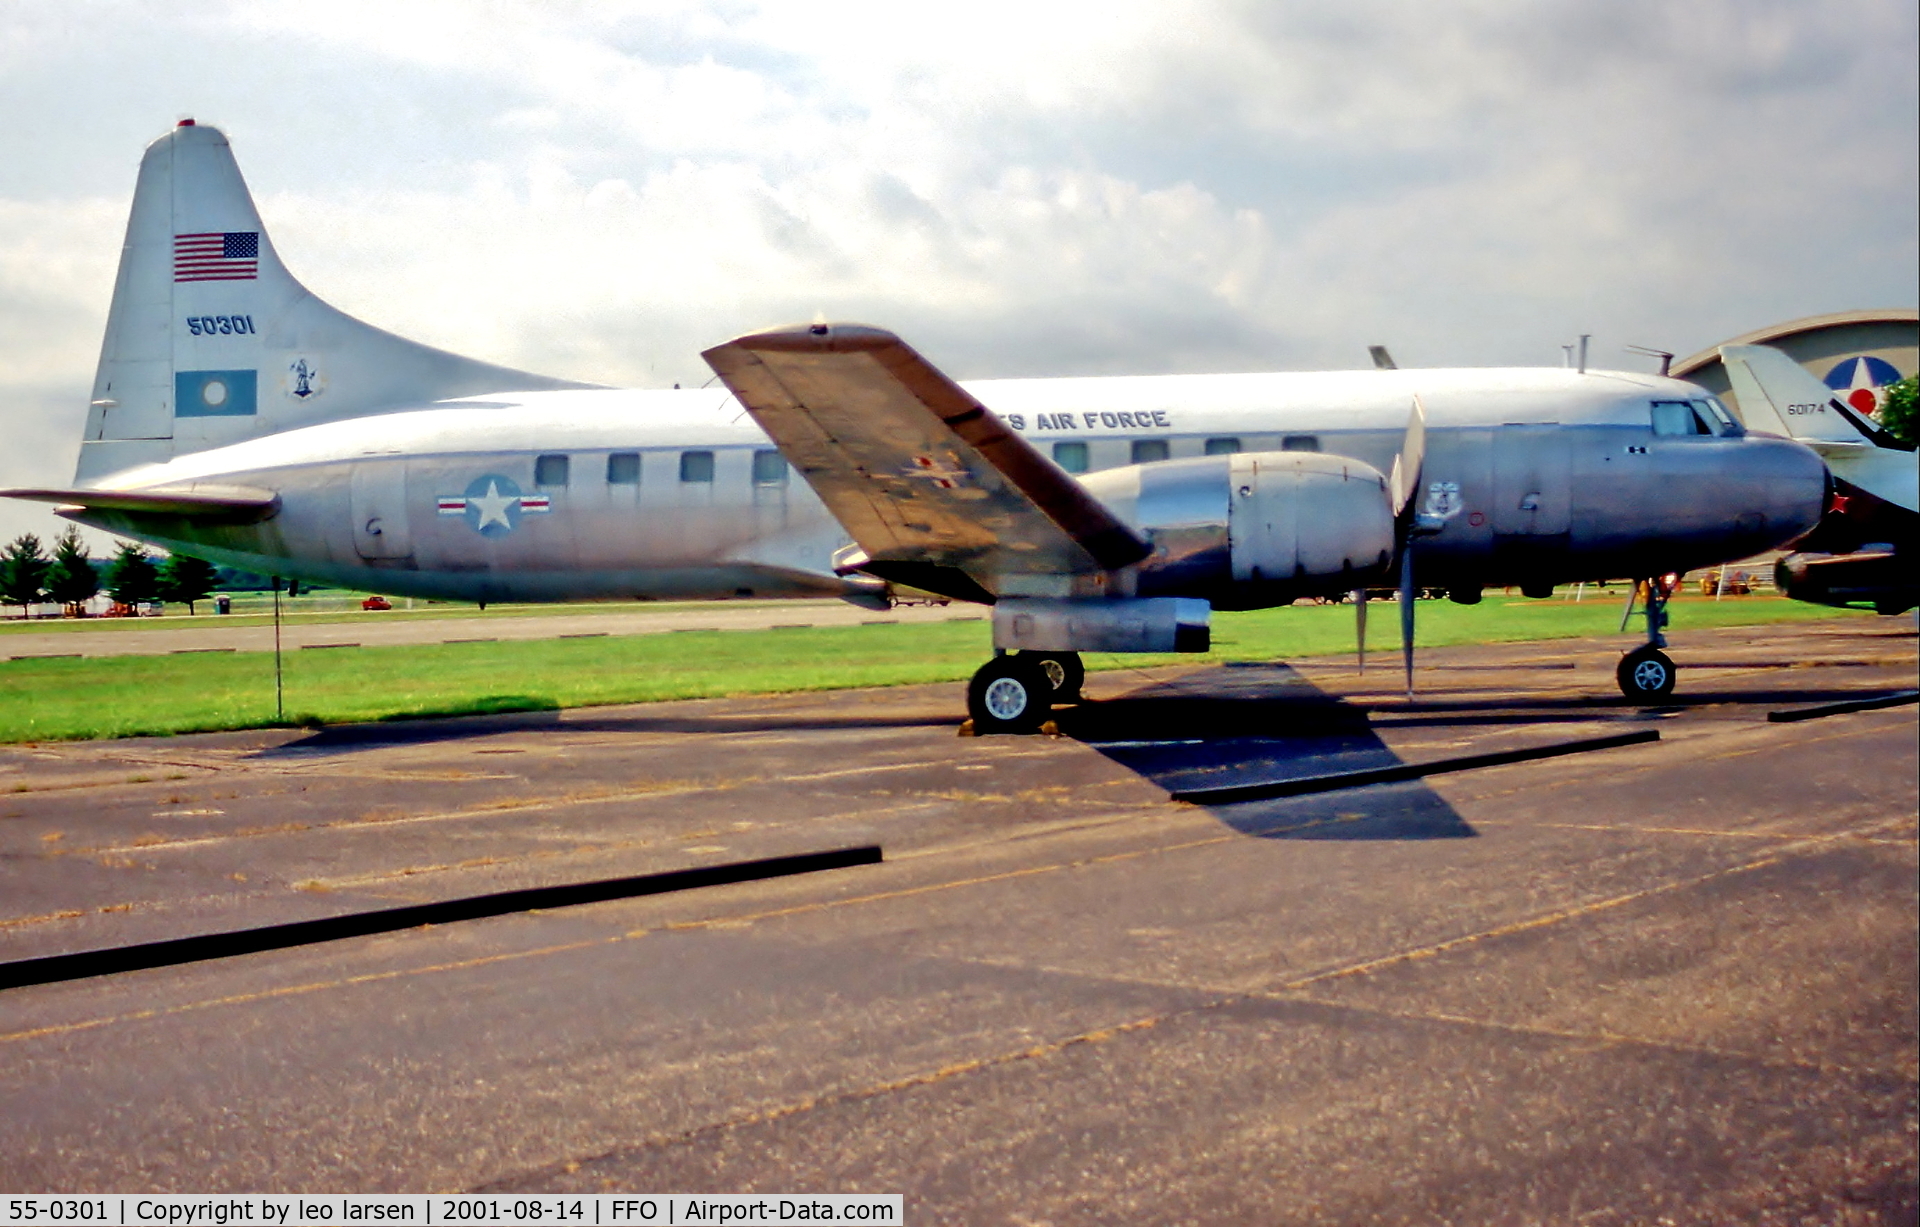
[1081,451,1394,609]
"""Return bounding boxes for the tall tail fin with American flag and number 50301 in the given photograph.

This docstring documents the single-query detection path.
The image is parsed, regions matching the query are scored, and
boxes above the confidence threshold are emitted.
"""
[75,119,591,482]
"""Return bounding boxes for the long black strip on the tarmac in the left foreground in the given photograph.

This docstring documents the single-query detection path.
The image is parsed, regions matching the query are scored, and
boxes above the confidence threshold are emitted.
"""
[0,845,881,991]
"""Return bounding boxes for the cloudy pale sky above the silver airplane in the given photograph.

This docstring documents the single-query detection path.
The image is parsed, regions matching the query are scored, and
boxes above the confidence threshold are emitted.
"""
[0,0,1920,540]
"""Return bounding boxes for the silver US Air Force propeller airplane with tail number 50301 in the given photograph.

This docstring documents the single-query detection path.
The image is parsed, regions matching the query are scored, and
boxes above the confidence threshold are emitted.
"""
[4,121,1828,732]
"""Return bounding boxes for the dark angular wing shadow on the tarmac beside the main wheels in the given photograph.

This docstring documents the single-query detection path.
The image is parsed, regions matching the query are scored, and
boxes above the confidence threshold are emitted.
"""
[1056,664,1476,839]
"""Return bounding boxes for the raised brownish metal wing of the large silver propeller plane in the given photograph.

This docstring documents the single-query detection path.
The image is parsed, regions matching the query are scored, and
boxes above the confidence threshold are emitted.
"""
[703,325,1148,599]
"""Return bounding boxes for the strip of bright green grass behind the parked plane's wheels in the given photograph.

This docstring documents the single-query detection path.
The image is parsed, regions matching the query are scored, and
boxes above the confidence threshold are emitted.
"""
[0,593,1870,741]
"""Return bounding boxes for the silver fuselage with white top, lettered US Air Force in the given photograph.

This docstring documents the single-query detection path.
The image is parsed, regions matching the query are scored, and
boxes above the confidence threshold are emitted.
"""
[65,369,1826,607]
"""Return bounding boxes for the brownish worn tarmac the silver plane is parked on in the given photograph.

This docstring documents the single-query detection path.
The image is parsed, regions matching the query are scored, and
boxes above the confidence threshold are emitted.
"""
[0,618,1920,1223]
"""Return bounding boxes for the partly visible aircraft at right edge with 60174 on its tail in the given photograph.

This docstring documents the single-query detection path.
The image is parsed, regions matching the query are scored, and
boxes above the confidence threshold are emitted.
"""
[1720,346,1920,614]
